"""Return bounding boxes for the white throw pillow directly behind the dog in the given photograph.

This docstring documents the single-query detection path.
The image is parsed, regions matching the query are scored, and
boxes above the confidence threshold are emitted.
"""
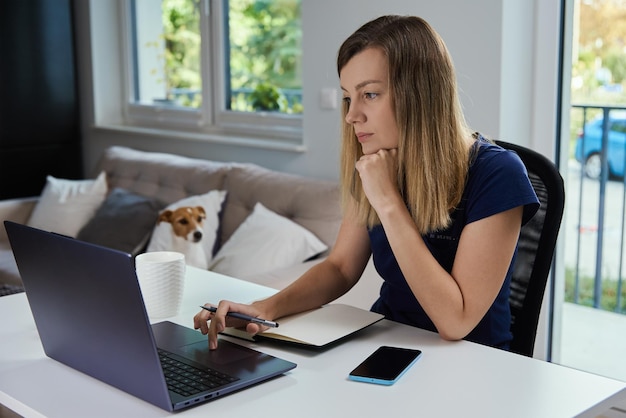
[146,190,226,269]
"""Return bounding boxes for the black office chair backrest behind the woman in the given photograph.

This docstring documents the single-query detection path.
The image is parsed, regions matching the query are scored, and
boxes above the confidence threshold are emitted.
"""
[495,140,565,357]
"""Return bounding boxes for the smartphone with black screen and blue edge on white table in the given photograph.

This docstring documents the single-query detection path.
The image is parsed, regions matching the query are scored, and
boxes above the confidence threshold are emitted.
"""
[348,346,422,386]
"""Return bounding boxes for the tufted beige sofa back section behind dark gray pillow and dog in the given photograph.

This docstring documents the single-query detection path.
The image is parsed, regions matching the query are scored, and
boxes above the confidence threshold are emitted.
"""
[98,146,230,205]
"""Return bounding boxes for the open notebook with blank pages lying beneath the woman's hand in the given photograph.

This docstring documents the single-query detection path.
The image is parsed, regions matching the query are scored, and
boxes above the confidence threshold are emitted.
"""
[222,303,384,348]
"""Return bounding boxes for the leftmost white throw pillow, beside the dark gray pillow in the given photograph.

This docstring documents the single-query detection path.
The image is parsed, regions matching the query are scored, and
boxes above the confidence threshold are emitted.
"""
[27,171,108,238]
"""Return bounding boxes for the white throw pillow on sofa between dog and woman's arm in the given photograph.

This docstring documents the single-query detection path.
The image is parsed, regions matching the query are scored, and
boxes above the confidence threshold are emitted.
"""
[209,203,328,277]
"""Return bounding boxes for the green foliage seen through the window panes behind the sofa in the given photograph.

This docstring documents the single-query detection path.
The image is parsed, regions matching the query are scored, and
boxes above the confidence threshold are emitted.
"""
[157,0,303,113]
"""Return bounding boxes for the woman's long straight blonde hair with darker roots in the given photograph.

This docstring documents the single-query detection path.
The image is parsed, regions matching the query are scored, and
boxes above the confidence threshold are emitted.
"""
[337,16,471,234]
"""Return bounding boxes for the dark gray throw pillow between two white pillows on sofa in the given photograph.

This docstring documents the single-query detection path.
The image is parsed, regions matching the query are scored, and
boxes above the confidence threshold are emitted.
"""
[76,188,163,256]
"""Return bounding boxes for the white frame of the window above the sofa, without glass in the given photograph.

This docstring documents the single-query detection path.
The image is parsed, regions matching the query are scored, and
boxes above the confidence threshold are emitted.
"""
[119,0,303,150]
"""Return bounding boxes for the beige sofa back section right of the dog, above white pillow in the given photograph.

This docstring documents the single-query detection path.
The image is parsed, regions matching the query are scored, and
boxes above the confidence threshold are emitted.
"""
[221,164,341,247]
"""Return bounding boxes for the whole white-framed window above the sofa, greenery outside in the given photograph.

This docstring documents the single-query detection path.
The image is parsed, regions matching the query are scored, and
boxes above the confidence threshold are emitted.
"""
[122,0,303,144]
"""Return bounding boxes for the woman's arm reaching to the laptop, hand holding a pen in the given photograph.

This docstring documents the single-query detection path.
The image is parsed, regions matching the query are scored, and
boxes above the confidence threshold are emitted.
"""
[194,202,371,349]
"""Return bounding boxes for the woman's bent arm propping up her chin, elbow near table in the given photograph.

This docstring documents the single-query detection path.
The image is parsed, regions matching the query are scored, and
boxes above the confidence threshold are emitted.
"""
[356,149,522,340]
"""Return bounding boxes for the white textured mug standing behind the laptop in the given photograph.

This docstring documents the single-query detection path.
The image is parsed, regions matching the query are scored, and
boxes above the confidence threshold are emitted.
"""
[135,251,185,319]
